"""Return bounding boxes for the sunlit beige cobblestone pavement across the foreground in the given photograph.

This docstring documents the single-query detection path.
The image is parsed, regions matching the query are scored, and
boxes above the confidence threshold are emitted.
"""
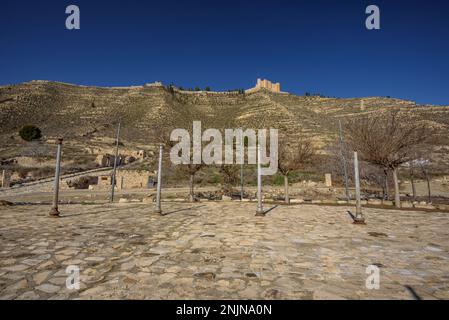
[0,202,449,299]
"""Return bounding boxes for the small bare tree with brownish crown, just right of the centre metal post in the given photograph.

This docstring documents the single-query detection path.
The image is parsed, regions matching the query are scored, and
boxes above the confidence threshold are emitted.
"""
[278,139,315,204]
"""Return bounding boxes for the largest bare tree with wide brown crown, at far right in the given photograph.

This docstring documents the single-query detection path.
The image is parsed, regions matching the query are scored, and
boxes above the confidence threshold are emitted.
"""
[346,111,431,208]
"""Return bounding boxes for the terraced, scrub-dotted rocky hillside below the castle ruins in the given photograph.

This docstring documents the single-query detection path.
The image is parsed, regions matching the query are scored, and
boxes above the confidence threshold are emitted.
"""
[0,81,449,157]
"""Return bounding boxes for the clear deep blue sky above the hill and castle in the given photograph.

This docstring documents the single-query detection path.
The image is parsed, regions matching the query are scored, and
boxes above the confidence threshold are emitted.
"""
[0,0,449,105]
